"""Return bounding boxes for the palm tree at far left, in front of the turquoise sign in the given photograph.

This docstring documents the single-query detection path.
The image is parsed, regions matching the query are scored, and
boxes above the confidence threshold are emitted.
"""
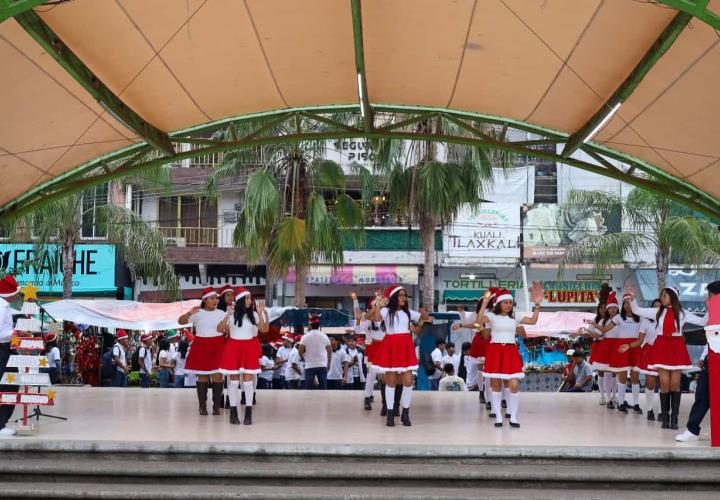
[10,190,179,299]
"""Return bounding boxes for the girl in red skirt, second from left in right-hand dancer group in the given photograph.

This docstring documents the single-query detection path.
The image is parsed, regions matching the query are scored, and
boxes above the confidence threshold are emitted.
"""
[609,295,642,415]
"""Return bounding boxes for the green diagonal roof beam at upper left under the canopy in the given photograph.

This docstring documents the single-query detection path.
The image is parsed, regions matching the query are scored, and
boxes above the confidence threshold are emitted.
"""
[15,10,175,156]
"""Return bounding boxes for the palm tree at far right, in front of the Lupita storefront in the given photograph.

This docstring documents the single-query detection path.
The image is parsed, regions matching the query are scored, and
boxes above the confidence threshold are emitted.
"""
[562,188,720,292]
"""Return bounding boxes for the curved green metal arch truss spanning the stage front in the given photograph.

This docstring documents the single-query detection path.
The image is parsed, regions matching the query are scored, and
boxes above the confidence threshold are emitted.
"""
[0,104,720,221]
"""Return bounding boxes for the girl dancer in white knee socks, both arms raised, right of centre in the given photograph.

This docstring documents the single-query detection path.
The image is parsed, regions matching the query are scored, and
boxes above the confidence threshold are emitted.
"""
[478,289,542,427]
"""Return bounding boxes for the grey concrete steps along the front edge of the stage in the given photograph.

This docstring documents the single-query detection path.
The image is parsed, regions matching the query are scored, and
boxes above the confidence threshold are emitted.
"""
[0,450,720,500]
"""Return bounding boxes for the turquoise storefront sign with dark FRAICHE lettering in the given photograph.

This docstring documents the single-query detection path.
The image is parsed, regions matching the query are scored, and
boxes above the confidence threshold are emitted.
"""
[0,243,115,294]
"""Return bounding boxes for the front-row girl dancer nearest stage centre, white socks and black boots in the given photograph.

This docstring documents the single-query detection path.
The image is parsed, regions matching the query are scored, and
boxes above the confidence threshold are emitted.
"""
[368,285,420,427]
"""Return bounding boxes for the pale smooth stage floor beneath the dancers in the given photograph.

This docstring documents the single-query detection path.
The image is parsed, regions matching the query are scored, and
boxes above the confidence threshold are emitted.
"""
[0,386,720,459]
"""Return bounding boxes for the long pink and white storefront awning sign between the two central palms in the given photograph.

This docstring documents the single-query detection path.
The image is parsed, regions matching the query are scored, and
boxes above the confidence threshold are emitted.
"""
[285,266,418,285]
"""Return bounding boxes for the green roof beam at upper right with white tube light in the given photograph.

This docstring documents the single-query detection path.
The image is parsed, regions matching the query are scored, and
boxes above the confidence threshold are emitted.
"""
[562,10,692,158]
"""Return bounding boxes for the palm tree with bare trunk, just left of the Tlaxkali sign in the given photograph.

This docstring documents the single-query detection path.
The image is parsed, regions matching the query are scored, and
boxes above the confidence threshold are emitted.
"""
[373,118,496,311]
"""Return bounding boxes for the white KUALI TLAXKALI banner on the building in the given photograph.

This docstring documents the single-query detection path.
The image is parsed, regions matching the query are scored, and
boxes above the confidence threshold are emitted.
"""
[443,203,520,258]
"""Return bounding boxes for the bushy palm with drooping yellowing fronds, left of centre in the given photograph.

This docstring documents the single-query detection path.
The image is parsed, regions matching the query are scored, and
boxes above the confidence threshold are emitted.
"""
[205,118,373,307]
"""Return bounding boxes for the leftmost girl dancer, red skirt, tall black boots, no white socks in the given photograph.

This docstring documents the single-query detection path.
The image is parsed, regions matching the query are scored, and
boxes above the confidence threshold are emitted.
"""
[178,287,225,415]
